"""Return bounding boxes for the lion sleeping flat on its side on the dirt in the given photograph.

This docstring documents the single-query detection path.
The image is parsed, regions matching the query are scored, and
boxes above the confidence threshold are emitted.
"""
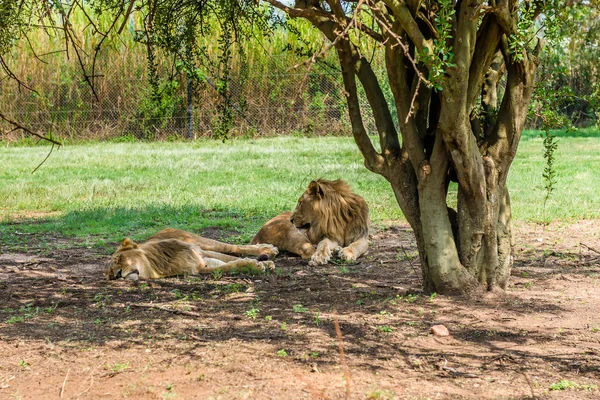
[106,228,277,281]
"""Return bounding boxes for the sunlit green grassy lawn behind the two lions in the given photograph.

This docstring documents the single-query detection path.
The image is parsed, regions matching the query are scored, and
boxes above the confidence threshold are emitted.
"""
[0,131,600,249]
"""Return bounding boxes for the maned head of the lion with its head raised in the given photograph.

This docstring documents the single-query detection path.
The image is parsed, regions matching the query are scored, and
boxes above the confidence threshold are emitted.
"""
[291,179,369,245]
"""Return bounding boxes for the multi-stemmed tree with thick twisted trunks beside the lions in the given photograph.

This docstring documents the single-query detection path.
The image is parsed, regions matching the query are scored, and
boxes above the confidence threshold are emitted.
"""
[260,0,553,293]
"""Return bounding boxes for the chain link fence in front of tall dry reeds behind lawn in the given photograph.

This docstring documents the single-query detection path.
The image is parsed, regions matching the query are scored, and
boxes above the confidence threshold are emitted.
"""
[0,58,599,139]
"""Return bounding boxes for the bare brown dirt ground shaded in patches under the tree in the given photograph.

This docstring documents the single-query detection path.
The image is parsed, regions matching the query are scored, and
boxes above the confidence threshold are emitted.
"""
[0,221,600,399]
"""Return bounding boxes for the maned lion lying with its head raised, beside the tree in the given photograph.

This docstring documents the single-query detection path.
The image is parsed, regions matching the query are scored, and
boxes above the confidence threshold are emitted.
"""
[250,179,369,266]
